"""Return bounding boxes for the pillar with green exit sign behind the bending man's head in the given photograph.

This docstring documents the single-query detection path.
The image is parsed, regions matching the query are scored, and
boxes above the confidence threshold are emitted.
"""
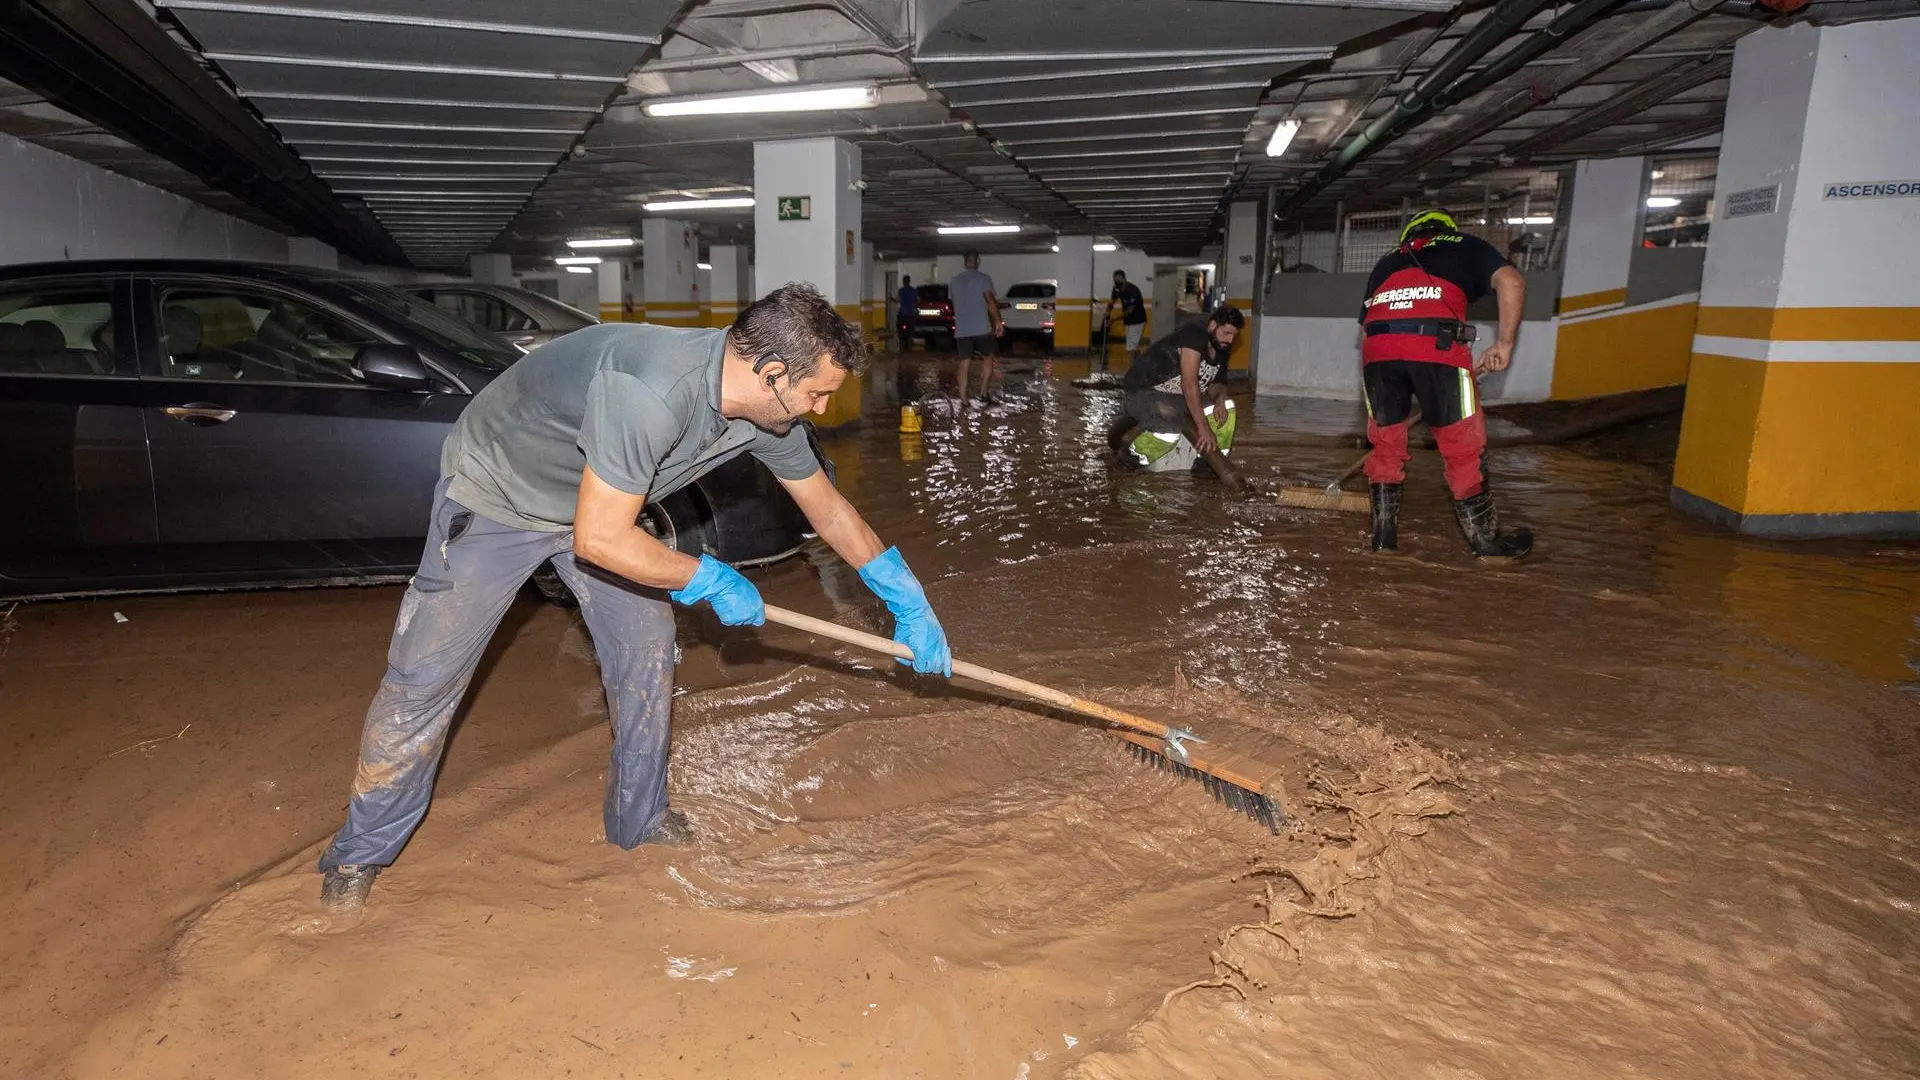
[753,138,862,427]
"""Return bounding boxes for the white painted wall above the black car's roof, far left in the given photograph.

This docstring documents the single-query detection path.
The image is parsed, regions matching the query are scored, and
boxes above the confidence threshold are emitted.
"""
[0,135,286,263]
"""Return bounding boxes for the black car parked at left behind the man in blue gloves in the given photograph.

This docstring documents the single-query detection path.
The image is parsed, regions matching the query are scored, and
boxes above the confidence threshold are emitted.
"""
[0,261,818,598]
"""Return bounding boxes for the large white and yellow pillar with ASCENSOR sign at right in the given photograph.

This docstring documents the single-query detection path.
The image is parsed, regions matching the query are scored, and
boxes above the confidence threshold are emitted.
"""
[1672,19,1920,536]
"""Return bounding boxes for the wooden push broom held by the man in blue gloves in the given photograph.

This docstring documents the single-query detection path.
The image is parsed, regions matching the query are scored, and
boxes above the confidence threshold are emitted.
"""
[766,603,1286,832]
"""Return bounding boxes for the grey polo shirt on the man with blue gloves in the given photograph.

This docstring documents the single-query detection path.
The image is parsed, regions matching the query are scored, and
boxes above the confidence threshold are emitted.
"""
[440,323,820,532]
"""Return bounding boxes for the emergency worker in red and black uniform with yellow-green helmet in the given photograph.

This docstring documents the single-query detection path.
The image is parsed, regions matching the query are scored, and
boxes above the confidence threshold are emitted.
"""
[1359,209,1534,559]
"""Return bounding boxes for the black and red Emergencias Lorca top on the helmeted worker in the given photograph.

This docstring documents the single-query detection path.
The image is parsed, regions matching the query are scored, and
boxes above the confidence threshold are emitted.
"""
[1359,234,1507,367]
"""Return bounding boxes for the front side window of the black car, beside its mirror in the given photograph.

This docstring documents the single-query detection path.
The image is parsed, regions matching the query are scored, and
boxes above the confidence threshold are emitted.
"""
[159,286,380,386]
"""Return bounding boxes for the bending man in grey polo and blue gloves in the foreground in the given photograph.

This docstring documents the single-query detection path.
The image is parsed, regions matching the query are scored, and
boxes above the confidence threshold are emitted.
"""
[321,284,952,917]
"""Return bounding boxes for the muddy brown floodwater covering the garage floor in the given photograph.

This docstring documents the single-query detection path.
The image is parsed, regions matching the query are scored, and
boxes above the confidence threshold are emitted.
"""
[0,363,1920,1080]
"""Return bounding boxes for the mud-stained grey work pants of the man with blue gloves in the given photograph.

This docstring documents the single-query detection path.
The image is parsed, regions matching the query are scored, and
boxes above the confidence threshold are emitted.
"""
[321,480,674,871]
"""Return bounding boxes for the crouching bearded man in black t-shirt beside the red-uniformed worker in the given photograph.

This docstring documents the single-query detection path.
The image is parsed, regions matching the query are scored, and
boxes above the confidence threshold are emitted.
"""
[1106,304,1246,492]
